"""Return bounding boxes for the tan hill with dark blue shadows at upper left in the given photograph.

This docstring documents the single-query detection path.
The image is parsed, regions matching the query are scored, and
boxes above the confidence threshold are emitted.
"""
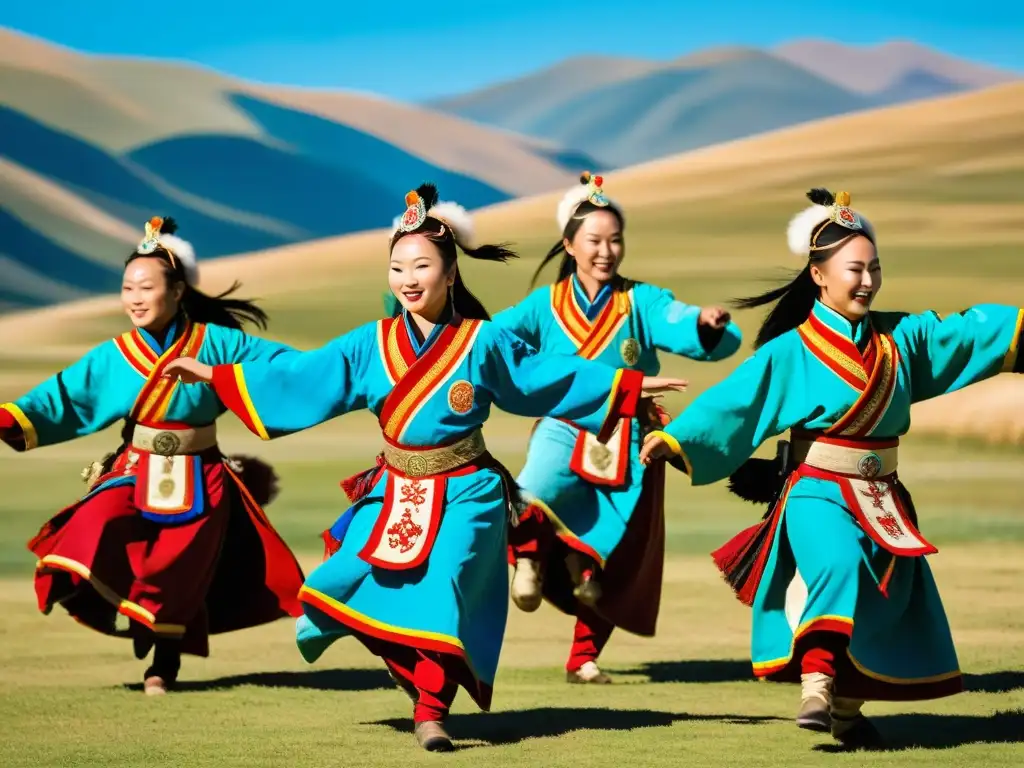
[0,30,590,310]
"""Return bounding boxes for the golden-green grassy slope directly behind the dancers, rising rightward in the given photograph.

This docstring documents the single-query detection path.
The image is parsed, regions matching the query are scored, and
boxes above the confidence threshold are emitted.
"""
[0,84,1024,444]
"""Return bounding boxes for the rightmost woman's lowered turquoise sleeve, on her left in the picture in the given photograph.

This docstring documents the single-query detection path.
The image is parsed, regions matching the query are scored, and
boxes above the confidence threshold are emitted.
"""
[652,347,812,485]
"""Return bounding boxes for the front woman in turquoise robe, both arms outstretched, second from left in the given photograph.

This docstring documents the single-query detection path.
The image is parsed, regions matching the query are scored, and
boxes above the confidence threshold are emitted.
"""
[163,184,684,751]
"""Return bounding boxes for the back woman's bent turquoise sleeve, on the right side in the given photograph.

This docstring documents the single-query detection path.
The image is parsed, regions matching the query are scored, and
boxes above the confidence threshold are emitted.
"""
[634,286,743,362]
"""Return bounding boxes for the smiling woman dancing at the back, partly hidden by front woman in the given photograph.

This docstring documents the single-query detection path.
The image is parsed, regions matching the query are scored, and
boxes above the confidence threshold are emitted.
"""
[495,173,740,683]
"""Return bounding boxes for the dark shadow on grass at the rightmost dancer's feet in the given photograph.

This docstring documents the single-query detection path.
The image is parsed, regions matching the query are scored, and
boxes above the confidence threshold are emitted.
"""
[815,710,1024,752]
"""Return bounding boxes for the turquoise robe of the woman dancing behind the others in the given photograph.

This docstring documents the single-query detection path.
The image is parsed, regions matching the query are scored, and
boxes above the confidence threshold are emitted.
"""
[495,274,741,564]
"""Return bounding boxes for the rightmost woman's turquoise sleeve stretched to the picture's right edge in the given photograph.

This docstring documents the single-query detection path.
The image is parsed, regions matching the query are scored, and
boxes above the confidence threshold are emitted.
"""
[897,304,1024,402]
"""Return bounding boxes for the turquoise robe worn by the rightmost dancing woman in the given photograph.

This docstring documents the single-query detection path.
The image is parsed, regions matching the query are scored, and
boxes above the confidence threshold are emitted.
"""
[660,303,1022,699]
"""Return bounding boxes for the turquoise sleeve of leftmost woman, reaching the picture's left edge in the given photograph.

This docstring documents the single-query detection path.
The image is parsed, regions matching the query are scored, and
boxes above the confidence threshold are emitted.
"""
[0,342,124,451]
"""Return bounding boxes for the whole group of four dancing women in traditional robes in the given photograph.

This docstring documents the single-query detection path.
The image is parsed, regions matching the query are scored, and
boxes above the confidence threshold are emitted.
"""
[0,174,1024,751]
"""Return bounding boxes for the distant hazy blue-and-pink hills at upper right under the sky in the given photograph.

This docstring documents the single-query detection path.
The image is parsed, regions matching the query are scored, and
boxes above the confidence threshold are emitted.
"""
[430,41,1015,168]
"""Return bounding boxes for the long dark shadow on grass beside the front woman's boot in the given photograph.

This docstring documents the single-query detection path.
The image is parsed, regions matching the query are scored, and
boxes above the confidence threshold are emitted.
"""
[369,707,785,749]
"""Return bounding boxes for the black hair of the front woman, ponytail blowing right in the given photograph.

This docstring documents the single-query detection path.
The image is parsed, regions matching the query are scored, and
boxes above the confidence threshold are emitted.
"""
[385,184,518,319]
